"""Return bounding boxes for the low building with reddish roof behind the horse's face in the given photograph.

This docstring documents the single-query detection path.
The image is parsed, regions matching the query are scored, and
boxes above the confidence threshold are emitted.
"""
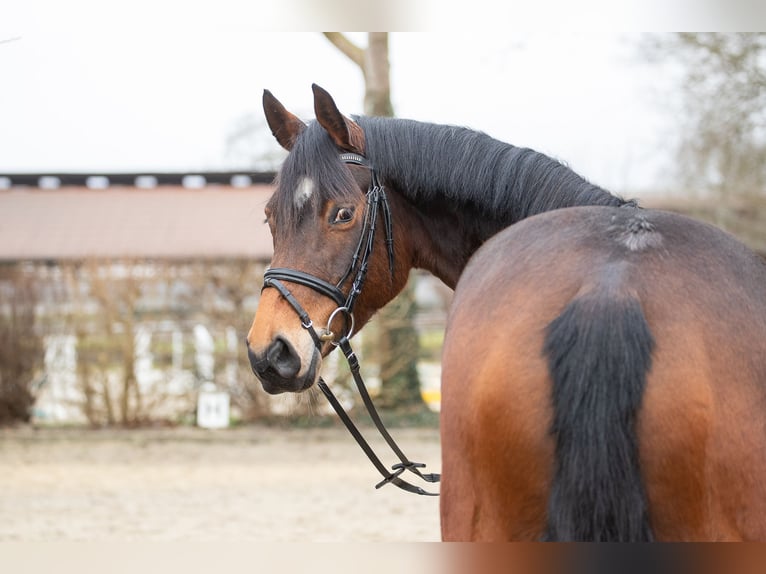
[0,173,273,424]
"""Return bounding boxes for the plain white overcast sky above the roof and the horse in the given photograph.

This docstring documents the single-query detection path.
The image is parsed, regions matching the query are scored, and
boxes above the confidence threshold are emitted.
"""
[0,0,752,197]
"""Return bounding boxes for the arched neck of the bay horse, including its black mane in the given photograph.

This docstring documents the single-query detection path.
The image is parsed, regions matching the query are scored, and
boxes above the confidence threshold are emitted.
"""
[360,118,625,287]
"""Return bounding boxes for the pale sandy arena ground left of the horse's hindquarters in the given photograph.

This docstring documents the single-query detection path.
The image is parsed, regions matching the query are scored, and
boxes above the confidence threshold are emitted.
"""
[0,427,440,542]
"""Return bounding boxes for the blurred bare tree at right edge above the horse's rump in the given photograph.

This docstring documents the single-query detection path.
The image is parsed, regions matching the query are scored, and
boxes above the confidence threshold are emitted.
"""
[645,33,766,252]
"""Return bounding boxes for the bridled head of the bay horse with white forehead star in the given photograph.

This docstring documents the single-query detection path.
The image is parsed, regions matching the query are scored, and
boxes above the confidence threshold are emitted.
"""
[247,85,410,394]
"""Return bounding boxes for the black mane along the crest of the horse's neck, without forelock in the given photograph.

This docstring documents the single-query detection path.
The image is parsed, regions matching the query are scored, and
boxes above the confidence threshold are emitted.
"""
[356,117,625,224]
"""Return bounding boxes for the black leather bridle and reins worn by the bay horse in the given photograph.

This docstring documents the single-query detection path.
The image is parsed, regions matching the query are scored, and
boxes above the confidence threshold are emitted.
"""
[263,153,440,496]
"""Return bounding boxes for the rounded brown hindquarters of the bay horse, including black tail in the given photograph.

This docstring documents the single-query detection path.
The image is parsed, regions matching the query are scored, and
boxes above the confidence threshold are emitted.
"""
[442,207,766,540]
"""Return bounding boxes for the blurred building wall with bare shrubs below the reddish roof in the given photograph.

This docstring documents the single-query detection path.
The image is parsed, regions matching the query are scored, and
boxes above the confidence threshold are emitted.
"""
[11,260,266,425]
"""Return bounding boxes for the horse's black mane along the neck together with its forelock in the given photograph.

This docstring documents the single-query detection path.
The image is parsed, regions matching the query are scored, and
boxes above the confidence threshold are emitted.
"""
[275,117,626,227]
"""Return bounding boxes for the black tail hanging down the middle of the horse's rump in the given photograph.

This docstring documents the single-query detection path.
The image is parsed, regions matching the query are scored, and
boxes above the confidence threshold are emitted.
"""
[545,292,654,542]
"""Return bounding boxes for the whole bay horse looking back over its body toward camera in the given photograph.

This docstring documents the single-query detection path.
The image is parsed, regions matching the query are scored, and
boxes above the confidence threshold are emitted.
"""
[247,85,766,541]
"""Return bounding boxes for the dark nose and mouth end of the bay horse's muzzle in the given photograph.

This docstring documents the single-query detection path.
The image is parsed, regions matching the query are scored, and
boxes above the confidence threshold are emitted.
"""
[247,337,319,395]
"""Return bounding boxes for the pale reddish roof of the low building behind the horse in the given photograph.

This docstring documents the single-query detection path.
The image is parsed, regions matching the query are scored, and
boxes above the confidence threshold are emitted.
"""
[0,184,273,261]
